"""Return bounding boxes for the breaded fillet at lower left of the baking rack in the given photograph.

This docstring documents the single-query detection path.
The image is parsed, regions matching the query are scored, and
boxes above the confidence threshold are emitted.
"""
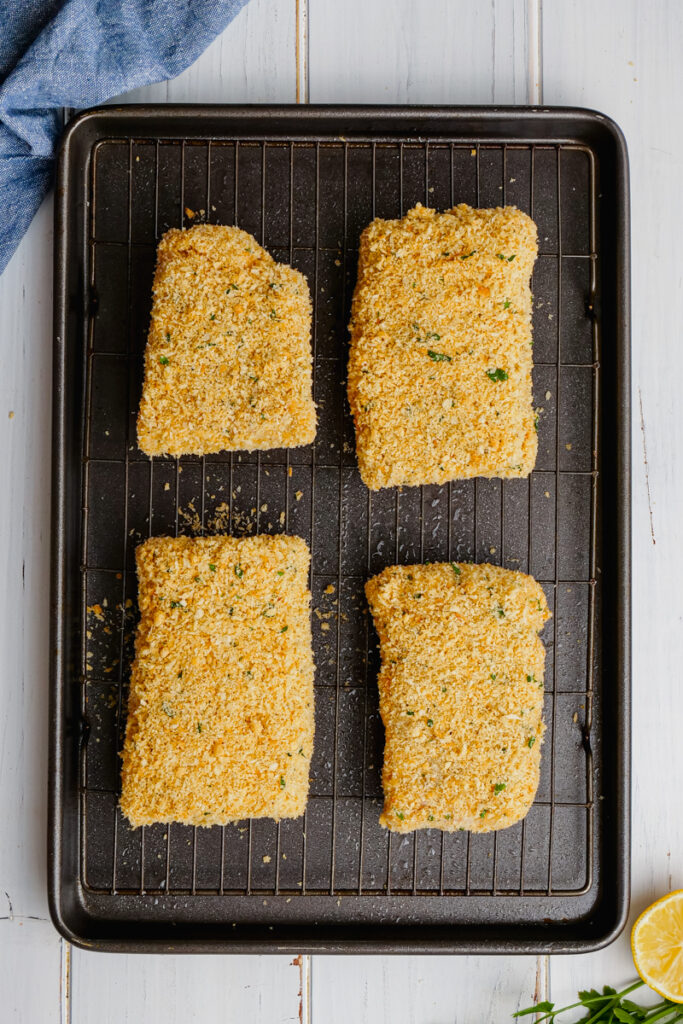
[121,536,313,826]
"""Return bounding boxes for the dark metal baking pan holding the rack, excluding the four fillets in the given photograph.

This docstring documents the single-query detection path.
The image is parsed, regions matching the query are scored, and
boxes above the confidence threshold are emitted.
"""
[49,106,630,952]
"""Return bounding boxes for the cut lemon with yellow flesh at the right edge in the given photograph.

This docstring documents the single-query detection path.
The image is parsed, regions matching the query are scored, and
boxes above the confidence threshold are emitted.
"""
[631,889,683,1002]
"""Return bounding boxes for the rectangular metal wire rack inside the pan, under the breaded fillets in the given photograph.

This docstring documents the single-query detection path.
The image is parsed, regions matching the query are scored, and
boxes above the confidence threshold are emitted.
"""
[80,132,600,899]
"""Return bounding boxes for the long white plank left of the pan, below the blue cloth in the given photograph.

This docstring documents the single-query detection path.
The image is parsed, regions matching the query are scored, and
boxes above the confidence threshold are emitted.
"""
[0,193,52,918]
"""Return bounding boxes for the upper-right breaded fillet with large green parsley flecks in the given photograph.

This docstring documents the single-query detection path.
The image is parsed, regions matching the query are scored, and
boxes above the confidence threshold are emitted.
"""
[348,205,538,489]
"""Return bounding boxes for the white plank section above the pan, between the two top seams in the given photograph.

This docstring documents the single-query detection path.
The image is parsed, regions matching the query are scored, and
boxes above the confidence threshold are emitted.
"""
[308,0,527,103]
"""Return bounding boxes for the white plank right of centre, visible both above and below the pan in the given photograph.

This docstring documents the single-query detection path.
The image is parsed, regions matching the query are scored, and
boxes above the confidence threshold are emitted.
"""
[308,0,547,1024]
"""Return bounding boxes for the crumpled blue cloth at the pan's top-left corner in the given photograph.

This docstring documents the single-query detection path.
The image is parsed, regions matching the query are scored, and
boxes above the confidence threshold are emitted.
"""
[0,0,247,273]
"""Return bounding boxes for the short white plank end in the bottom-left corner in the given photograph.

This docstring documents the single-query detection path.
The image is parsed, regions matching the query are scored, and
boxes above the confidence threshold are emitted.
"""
[0,921,66,1024]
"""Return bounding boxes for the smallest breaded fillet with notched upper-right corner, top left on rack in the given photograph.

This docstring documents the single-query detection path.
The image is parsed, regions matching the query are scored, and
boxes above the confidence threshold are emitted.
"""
[137,224,315,456]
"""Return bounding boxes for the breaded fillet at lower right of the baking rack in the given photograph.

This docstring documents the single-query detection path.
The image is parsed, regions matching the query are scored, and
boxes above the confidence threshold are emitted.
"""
[366,562,550,833]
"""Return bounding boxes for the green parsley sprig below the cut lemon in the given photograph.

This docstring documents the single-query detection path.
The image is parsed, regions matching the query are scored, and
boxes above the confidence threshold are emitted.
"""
[512,981,683,1024]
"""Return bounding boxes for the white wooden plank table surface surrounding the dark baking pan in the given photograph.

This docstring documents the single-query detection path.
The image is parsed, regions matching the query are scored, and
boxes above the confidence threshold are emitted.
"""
[0,0,683,1024]
